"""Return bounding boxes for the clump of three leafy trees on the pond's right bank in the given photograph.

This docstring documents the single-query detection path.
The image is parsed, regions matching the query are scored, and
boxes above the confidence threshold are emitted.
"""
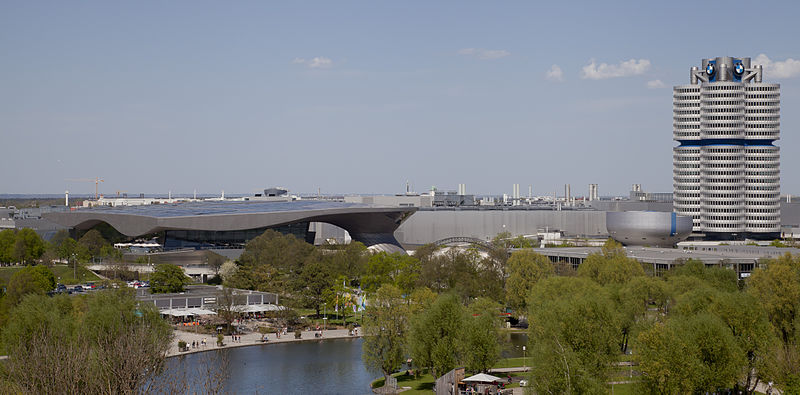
[362,284,501,386]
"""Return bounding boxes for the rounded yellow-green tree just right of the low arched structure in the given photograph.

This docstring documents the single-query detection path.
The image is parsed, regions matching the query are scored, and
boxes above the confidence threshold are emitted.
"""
[505,250,553,312]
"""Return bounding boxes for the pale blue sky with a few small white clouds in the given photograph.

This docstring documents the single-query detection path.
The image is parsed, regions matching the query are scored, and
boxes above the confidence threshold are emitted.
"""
[0,1,800,195]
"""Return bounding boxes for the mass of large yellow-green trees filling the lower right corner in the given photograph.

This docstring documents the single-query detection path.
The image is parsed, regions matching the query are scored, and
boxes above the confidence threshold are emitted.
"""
[527,243,800,394]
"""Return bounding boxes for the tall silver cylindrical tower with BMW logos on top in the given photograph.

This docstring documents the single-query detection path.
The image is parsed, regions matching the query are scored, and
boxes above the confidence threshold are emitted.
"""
[673,57,780,239]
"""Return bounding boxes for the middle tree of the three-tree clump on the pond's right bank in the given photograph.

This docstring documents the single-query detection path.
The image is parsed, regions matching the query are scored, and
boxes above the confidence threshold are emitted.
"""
[408,293,465,377]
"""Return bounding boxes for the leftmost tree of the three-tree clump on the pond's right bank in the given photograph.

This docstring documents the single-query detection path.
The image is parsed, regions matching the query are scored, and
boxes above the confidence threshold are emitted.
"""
[362,284,408,386]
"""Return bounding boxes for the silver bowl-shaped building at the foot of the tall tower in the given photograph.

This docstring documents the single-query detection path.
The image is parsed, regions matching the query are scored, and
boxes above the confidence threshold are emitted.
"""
[606,211,692,247]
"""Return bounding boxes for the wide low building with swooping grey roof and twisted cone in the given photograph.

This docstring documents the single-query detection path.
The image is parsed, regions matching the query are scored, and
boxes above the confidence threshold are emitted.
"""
[44,200,417,252]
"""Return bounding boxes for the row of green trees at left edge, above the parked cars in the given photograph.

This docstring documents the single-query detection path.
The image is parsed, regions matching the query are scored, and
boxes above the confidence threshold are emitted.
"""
[0,228,122,265]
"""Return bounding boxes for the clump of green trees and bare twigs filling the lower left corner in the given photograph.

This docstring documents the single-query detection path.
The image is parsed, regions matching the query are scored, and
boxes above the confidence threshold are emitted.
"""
[0,289,174,394]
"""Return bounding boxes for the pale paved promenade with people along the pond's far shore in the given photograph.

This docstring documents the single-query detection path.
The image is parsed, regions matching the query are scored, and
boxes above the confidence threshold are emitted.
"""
[166,329,361,358]
